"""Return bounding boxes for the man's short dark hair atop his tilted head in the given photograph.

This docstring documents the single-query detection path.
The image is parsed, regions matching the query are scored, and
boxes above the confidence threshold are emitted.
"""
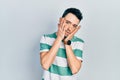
[62,8,83,21]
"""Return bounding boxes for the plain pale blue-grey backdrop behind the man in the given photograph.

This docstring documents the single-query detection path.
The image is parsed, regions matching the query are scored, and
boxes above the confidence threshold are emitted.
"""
[0,0,120,80]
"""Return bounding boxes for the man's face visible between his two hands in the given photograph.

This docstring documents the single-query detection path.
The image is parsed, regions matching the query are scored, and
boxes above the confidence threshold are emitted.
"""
[64,13,80,36]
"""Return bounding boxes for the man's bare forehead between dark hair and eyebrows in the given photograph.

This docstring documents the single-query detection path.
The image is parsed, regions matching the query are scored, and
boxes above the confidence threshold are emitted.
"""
[65,13,80,24]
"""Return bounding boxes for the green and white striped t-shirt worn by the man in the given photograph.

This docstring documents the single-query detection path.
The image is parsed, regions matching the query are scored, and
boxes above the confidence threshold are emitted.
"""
[40,32,84,80]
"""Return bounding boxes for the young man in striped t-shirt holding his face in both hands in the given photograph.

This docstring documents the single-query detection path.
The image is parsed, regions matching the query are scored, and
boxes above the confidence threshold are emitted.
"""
[40,8,84,80]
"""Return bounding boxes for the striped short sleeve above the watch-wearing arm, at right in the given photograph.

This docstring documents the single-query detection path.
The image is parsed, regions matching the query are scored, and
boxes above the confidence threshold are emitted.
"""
[74,42,84,61]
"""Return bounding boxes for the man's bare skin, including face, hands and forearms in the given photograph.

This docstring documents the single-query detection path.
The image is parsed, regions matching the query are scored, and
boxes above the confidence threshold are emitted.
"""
[40,13,82,74]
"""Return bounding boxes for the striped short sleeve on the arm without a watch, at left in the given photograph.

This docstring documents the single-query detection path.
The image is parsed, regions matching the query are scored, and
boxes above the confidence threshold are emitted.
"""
[40,35,50,52]
